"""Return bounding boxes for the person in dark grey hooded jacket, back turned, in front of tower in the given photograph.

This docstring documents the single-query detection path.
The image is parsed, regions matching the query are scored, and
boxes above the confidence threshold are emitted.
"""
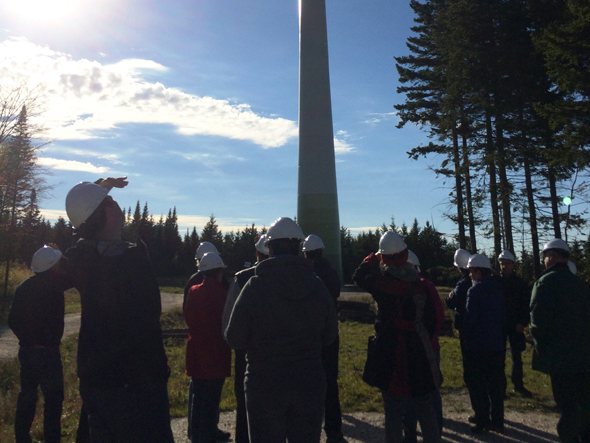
[225,217,338,443]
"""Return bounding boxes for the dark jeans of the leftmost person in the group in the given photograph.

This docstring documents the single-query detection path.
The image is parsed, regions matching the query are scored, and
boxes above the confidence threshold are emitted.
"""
[14,348,64,443]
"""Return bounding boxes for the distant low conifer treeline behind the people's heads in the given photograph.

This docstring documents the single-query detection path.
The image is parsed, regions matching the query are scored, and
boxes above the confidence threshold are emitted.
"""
[2,201,456,284]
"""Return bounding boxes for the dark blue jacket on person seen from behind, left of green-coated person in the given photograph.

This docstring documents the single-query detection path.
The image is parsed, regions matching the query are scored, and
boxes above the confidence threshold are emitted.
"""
[461,276,506,352]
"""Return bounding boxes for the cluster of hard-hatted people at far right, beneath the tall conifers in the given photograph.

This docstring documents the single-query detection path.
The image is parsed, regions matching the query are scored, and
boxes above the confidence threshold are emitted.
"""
[446,243,590,443]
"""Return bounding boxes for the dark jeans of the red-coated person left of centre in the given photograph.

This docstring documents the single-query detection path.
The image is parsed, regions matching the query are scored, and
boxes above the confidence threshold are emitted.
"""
[189,377,225,443]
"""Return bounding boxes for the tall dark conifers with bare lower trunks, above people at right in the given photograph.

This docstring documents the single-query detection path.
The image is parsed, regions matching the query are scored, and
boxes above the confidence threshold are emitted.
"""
[395,0,590,274]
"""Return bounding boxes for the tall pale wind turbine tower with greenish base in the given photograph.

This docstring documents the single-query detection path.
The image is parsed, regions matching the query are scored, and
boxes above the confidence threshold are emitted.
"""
[297,0,342,278]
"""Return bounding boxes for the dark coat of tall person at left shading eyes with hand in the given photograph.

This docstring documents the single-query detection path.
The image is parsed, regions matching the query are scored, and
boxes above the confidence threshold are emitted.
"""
[66,239,169,386]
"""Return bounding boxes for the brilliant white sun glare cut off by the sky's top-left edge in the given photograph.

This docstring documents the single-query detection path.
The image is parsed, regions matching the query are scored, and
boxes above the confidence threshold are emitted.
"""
[5,0,82,23]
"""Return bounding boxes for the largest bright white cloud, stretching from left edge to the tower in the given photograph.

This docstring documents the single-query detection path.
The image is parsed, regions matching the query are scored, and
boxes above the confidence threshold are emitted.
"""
[0,38,297,148]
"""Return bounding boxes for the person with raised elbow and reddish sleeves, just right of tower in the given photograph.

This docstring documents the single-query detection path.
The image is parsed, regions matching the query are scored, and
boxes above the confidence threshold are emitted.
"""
[352,231,441,443]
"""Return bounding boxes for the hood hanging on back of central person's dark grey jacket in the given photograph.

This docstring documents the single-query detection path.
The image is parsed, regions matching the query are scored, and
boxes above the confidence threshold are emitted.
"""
[256,255,319,300]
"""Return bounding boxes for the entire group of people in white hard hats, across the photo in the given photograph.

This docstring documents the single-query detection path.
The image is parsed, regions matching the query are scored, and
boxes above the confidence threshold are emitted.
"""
[9,177,590,443]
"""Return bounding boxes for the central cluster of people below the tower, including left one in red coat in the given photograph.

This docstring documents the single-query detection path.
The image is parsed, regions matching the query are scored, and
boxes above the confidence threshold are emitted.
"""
[184,217,344,443]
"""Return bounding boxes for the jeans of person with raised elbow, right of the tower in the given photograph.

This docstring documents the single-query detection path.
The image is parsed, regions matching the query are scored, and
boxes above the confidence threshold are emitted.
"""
[381,391,441,443]
